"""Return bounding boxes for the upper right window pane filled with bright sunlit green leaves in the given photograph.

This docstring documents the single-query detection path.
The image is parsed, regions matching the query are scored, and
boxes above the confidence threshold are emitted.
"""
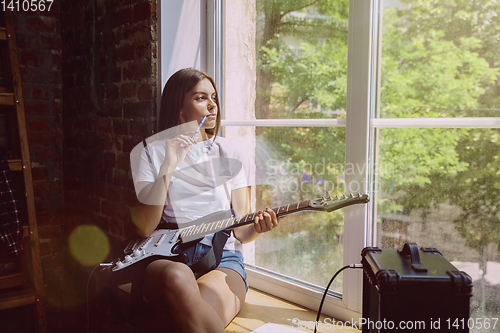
[380,0,500,118]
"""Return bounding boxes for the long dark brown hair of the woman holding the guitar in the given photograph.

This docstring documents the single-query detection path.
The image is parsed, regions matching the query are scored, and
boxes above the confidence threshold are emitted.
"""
[158,68,220,136]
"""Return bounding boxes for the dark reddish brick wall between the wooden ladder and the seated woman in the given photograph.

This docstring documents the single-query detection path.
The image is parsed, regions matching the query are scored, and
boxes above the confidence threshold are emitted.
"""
[10,0,157,332]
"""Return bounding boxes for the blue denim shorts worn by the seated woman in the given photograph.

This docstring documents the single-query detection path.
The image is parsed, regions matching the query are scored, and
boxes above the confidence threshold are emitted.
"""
[184,243,248,291]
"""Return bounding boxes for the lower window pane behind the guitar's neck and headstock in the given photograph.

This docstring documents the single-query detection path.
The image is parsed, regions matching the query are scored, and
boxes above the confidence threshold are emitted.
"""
[254,127,345,291]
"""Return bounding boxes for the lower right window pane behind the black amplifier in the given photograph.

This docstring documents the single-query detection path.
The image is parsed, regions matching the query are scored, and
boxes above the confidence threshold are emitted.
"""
[376,128,500,318]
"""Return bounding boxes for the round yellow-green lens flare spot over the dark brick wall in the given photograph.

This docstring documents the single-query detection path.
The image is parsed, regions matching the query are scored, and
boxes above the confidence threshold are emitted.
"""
[68,224,109,266]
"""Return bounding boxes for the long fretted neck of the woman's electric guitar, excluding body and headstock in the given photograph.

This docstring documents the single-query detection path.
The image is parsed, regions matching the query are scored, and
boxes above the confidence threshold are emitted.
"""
[180,200,310,242]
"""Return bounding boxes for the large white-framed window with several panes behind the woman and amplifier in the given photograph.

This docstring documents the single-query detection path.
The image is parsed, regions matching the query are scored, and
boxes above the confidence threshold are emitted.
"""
[161,0,500,321]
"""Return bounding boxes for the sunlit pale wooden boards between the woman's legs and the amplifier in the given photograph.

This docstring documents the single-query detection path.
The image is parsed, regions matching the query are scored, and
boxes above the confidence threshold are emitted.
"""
[226,289,360,333]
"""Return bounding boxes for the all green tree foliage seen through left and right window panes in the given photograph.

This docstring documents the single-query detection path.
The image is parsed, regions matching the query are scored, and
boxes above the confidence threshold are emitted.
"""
[256,0,500,251]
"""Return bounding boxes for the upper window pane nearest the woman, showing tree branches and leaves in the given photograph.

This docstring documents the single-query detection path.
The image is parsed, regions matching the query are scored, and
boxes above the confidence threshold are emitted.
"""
[255,0,348,119]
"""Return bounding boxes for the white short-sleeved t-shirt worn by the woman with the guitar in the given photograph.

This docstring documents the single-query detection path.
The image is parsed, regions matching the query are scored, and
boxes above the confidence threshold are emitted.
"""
[134,137,250,250]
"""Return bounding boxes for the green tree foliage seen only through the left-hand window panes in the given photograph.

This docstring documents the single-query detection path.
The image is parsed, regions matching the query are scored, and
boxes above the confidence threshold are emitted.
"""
[256,0,348,200]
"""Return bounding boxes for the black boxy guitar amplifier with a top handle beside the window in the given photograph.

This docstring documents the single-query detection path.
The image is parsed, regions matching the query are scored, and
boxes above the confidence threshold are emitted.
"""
[361,243,472,333]
